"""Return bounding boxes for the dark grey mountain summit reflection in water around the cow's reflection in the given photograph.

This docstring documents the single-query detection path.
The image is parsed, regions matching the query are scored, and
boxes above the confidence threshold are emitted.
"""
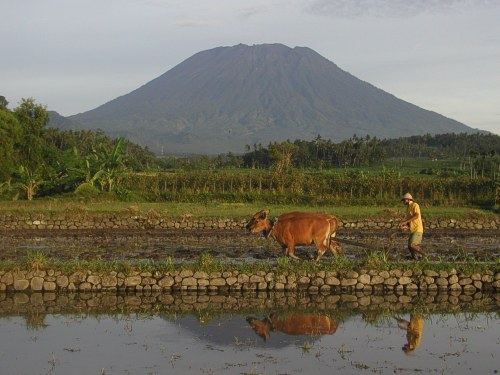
[160,314,338,349]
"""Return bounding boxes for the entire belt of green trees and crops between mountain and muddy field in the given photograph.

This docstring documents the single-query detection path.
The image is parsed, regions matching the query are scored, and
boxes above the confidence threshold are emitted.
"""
[0,97,500,216]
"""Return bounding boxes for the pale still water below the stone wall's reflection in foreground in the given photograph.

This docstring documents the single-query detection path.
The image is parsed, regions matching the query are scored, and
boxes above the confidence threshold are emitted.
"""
[0,296,500,375]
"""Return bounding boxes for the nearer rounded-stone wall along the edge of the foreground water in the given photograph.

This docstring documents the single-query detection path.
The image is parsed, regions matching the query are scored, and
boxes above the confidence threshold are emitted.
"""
[0,269,500,294]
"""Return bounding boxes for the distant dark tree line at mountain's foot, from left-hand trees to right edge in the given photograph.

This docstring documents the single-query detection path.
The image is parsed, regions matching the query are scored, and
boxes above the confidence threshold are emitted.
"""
[158,133,500,179]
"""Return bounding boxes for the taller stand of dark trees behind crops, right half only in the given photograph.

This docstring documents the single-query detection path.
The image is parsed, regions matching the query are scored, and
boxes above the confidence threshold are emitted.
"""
[243,133,500,169]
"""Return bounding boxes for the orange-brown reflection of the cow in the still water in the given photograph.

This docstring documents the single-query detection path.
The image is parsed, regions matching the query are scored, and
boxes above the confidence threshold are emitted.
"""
[247,314,338,340]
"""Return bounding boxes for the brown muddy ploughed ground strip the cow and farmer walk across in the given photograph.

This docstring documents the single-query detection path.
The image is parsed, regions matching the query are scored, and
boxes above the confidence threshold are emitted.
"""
[0,229,500,263]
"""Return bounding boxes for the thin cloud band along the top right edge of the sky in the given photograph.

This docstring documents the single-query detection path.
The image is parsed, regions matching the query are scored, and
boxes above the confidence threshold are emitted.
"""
[306,0,500,18]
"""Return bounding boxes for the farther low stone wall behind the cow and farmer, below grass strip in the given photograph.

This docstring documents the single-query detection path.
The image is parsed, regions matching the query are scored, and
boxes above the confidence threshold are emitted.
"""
[0,213,500,230]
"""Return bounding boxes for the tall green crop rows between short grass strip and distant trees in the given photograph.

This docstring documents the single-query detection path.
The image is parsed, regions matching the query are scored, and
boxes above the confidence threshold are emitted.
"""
[124,170,500,207]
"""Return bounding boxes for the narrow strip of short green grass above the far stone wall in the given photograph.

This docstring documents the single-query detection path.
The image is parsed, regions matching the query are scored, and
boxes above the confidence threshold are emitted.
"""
[0,198,494,219]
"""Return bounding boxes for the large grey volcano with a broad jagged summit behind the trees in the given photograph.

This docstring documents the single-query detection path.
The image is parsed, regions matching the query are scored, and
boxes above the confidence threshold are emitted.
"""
[55,44,473,154]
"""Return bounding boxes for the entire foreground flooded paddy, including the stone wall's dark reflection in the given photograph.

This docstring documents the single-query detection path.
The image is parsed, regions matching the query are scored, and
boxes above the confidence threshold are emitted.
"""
[0,294,500,374]
